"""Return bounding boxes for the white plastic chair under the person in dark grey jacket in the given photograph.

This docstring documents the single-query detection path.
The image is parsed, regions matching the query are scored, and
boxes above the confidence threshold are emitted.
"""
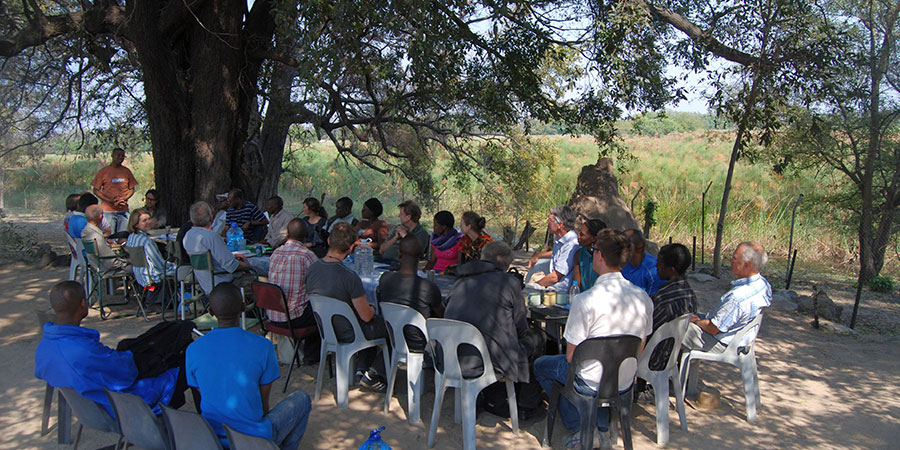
[425,319,519,450]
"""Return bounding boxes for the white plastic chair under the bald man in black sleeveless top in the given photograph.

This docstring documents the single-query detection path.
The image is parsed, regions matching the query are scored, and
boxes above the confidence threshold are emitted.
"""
[381,302,428,425]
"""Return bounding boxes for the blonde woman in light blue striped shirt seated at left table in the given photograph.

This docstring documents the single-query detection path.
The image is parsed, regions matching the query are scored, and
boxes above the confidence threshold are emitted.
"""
[125,208,175,303]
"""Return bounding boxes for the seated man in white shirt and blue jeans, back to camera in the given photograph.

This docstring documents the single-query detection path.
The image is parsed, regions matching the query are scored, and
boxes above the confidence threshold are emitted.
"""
[534,229,653,448]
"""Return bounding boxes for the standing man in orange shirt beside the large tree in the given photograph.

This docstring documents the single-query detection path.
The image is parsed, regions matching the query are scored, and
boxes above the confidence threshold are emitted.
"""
[91,147,137,233]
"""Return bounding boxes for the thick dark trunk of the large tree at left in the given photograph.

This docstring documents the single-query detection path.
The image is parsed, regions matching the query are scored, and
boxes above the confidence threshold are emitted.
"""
[127,0,274,224]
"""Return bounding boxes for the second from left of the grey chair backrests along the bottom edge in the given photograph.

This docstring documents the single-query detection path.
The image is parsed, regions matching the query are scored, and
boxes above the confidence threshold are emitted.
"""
[104,389,169,450]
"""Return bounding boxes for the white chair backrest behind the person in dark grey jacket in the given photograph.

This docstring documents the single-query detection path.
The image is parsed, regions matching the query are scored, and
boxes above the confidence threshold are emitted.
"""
[425,319,496,380]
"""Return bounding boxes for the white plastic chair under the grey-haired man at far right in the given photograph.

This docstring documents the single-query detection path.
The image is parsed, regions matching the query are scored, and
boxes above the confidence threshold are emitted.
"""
[681,312,763,422]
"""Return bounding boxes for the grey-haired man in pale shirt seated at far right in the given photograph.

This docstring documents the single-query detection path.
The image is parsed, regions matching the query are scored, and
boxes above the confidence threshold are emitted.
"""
[684,241,772,352]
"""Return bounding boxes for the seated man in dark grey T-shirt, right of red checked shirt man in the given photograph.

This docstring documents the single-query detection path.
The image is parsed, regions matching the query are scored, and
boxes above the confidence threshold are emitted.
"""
[304,222,388,392]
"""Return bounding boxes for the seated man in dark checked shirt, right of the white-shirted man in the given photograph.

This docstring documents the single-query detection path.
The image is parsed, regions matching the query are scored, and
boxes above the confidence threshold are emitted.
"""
[634,244,697,404]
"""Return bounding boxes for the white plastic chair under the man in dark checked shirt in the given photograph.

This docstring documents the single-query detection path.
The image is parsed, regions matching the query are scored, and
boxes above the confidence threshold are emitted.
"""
[637,314,691,445]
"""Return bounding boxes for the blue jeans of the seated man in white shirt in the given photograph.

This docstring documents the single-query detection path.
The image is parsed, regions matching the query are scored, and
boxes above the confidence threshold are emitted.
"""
[534,355,609,432]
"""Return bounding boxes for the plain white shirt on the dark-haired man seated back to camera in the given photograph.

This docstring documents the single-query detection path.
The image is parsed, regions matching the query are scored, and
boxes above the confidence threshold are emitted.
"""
[563,272,653,391]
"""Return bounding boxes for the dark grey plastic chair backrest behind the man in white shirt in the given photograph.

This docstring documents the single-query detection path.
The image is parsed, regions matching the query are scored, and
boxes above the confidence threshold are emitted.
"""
[566,335,642,400]
